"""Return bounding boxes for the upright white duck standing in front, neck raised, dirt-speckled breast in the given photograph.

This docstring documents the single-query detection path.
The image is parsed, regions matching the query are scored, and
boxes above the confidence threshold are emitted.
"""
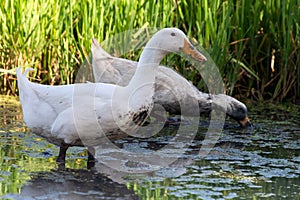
[17,28,206,163]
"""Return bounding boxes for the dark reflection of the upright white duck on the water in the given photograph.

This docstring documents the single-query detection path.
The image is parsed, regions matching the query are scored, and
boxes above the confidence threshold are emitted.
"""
[6,169,139,200]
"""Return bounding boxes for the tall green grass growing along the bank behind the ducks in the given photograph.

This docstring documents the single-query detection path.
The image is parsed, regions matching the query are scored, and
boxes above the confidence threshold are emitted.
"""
[0,0,300,101]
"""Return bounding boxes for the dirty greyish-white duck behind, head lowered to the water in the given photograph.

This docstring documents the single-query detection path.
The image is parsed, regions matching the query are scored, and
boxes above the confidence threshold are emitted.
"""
[92,39,251,127]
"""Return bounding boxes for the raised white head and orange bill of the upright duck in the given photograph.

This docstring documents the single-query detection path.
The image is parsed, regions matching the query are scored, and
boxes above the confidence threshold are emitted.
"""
[145,28,207,62]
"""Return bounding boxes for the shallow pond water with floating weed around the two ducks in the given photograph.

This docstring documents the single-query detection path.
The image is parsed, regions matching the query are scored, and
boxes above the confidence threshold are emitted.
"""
[0,97,300,199]
